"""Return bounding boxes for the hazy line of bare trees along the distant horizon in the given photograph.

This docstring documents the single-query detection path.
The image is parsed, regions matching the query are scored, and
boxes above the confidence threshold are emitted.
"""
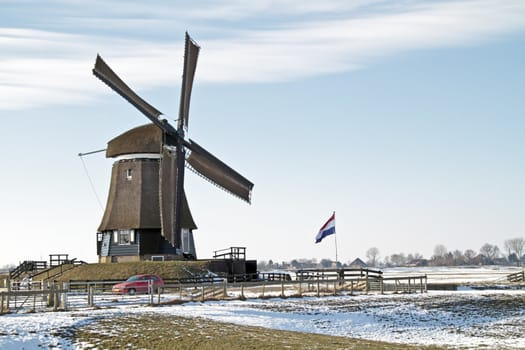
[258,237,525,271]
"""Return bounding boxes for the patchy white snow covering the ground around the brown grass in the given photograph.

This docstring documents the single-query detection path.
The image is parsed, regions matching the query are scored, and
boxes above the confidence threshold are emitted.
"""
[0,269,525,349]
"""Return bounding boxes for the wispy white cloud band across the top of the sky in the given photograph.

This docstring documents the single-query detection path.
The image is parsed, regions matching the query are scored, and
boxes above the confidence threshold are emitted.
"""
[0,0,525,110]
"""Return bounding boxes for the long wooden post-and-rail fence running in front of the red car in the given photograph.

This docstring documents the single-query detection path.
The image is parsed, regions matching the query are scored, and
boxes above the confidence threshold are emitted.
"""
[0,276,427,314]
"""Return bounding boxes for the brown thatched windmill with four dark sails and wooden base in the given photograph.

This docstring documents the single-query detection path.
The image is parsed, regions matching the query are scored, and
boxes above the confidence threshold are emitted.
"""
[93,33,253,262]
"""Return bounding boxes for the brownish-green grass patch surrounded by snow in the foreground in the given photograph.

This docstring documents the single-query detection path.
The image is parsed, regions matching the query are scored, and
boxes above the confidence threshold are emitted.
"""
[72,314,444,350]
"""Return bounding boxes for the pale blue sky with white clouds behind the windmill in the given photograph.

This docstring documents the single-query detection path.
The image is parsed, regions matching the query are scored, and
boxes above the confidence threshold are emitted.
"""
[0,0,525,266]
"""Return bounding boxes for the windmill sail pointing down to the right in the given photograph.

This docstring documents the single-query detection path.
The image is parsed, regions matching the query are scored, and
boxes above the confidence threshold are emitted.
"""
[187,140,253,203]
